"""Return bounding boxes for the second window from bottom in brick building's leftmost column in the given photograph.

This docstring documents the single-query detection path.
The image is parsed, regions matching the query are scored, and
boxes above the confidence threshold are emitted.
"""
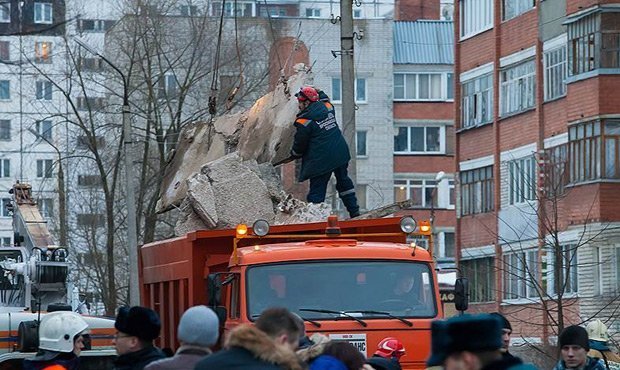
[461,166,494,216]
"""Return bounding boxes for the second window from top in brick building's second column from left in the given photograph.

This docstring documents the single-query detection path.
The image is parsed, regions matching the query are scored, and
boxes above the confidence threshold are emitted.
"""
[500,60,536,116]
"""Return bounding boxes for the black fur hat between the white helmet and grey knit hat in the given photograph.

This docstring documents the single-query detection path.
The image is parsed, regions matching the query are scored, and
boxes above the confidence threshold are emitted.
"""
[114,306,161,340]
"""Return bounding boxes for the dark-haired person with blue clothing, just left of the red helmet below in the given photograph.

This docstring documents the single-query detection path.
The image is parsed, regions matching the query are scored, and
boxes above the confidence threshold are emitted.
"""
[310,341,365,370]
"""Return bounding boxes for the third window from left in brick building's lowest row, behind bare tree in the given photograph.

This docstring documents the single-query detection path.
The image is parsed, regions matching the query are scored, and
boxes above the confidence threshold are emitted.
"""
[547,244,578,295]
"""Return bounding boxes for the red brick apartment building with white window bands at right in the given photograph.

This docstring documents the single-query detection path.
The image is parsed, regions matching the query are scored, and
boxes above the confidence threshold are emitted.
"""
[454,0,620,343]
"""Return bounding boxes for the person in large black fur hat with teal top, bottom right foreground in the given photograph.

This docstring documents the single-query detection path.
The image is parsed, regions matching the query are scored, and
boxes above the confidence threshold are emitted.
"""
[427,314,535,370]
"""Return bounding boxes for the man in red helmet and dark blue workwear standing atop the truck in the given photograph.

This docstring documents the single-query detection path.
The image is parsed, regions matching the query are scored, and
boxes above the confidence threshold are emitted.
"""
[291,86,359,217]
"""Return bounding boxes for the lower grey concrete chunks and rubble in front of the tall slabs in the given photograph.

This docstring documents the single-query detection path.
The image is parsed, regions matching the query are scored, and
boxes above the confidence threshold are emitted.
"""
[175,153,331,235]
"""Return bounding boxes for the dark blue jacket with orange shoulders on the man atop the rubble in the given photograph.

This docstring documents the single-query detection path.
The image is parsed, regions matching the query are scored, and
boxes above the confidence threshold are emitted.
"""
[291,94,351,181]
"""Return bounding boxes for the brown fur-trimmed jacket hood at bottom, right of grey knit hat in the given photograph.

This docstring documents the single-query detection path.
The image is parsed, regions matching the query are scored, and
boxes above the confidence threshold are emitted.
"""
[224,325,303,370]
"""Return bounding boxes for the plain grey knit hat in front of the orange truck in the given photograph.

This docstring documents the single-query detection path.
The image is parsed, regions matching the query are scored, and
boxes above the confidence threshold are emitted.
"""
[177,306,220,347]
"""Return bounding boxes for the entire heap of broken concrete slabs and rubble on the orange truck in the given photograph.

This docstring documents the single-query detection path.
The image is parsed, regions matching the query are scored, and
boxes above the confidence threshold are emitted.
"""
[157,65,331,235]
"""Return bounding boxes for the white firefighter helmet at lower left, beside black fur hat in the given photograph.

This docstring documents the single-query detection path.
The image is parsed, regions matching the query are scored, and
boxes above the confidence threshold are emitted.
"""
[39,311,88,352]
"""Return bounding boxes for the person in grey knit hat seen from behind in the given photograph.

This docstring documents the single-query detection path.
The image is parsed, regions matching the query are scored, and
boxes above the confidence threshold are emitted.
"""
[144,306,220,370]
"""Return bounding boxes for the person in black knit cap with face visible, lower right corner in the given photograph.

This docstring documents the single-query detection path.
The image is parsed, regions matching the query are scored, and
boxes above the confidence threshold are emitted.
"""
[554,325,605,370]
